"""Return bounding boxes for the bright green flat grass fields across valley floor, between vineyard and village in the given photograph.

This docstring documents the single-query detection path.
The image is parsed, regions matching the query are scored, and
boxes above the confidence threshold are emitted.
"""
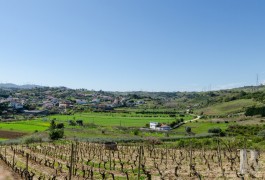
[0,113,235,141]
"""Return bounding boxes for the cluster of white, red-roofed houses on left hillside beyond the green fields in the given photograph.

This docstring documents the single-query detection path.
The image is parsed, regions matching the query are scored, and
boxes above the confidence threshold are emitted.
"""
[0,87,145,116]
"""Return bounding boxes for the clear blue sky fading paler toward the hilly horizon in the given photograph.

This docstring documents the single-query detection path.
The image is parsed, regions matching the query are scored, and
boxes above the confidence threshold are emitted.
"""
[0,0,265,91]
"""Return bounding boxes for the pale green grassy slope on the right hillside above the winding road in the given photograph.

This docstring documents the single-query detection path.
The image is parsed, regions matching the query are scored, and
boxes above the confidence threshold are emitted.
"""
[196,99,257,115]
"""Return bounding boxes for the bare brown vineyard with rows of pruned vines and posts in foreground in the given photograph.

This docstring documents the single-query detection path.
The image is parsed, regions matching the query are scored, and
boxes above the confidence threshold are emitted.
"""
[0,141,265,180]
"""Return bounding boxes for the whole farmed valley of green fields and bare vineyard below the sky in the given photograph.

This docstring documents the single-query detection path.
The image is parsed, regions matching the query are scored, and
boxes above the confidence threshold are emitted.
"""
[0,85,265,179]
